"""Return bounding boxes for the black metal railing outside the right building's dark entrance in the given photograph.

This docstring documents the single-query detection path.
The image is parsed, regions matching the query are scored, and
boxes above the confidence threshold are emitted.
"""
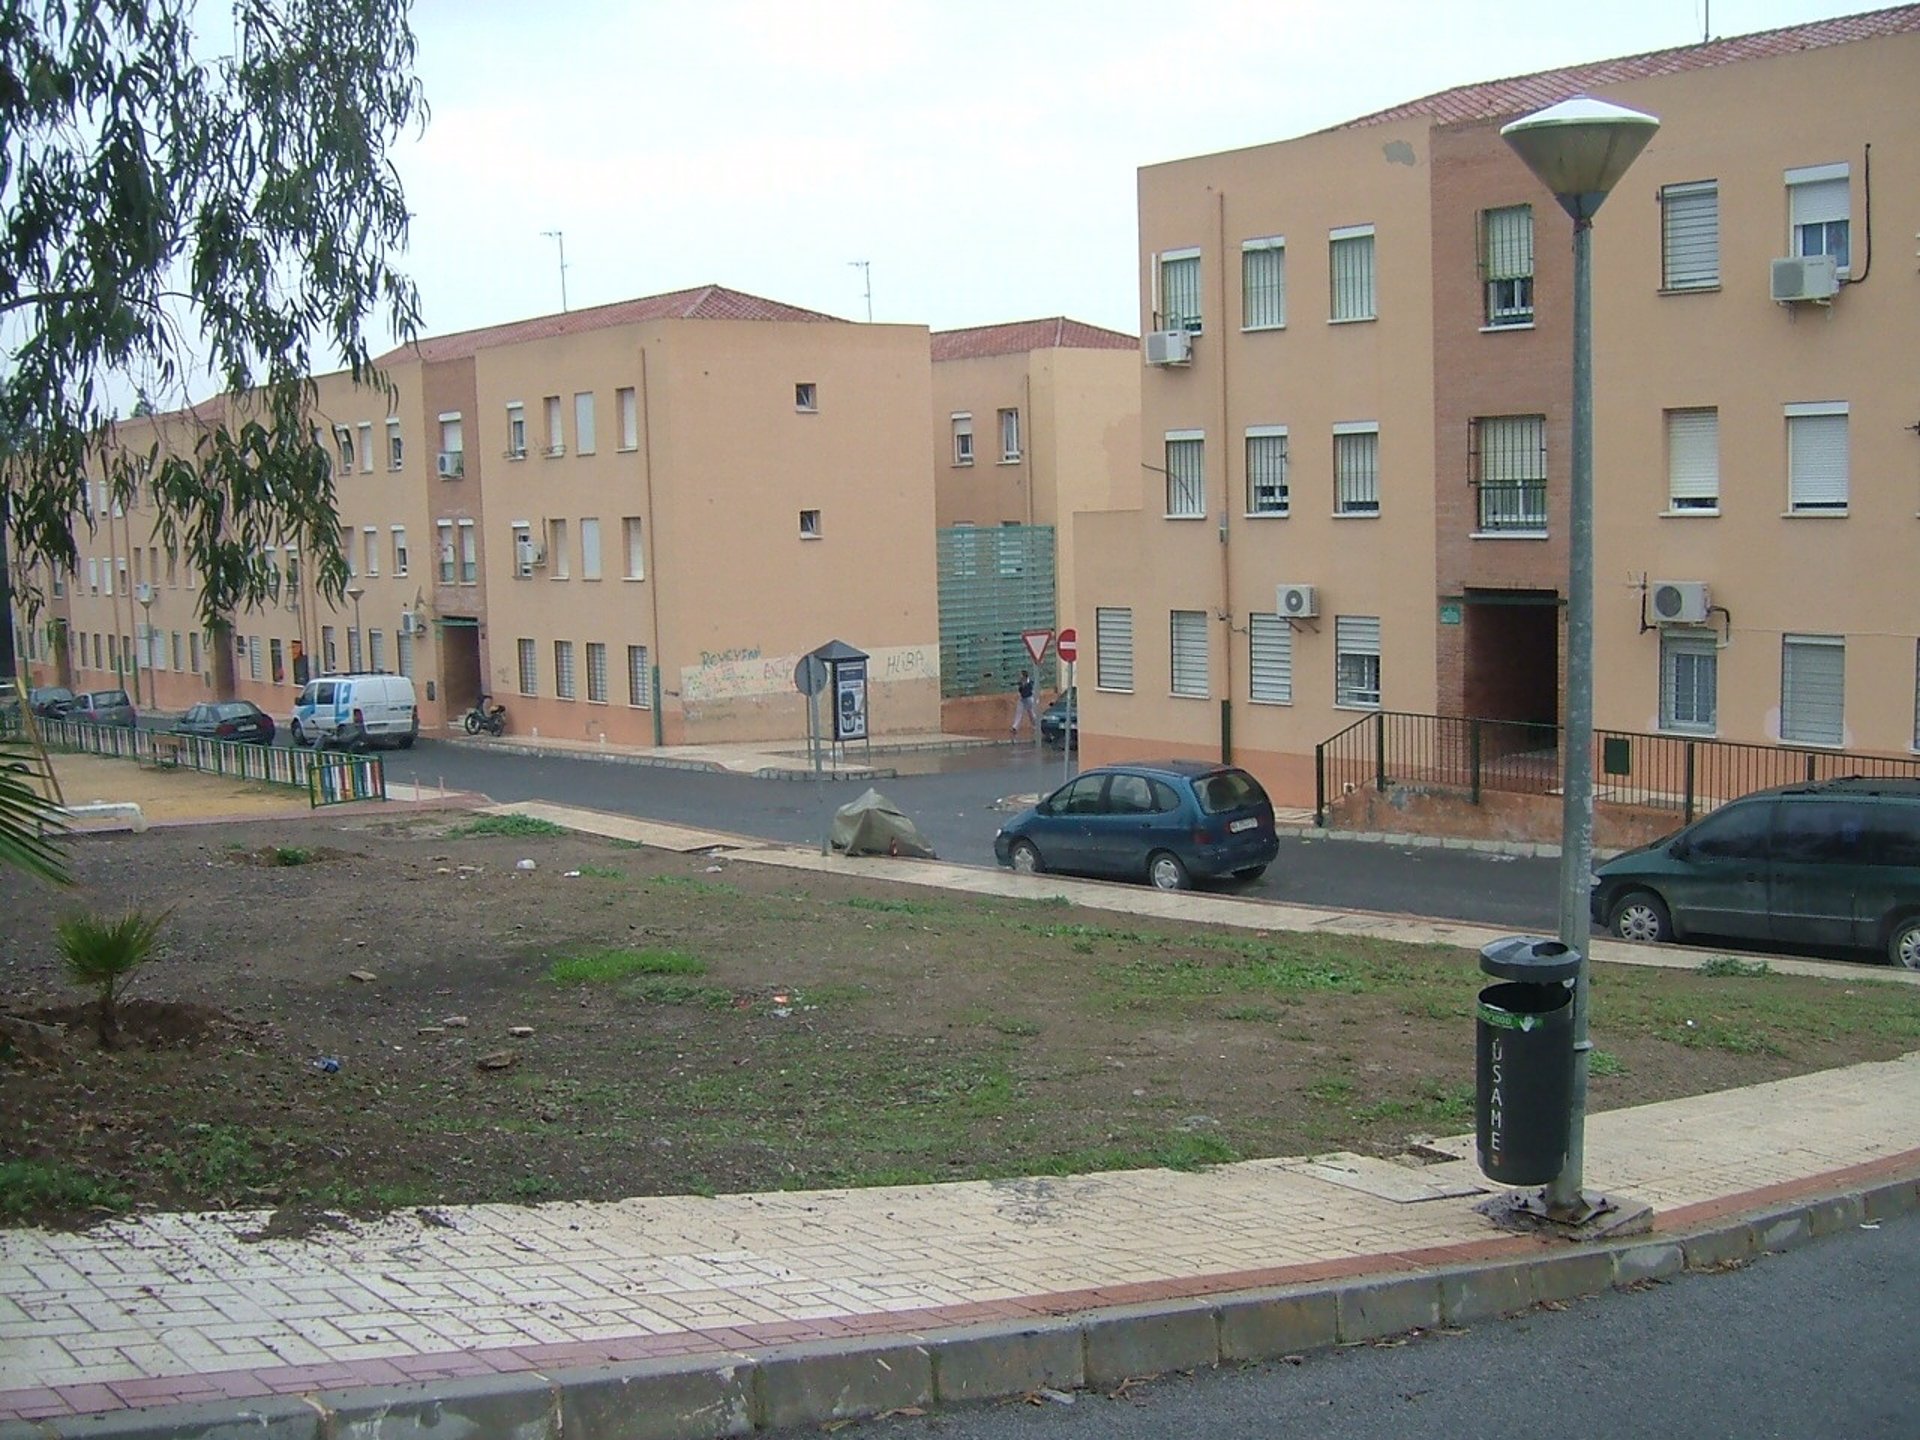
[1313,710,1920,826]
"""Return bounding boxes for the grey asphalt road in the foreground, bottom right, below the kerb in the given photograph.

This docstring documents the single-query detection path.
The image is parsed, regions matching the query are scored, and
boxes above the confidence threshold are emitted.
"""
[795,1213,1920,1440]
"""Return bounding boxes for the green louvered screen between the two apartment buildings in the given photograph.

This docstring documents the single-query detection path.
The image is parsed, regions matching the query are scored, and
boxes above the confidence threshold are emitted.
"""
[939,524,1060,699]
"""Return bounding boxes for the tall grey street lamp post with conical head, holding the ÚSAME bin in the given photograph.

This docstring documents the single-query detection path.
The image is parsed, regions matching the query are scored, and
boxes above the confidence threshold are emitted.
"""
[1500,96,1661,1223]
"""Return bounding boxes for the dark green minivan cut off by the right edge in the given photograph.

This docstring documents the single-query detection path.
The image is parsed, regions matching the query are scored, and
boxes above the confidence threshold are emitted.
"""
[1592,778,1920,970]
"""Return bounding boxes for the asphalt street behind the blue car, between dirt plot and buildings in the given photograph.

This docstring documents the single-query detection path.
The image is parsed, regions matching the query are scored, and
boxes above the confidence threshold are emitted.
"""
[366,739,1559,935]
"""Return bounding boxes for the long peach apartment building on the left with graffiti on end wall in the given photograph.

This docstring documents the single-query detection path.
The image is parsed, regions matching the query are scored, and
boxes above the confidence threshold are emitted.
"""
[25,286,939,745]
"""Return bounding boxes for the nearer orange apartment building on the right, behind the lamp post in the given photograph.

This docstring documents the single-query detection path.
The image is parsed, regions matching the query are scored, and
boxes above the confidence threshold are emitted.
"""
[1077,6,1920,804]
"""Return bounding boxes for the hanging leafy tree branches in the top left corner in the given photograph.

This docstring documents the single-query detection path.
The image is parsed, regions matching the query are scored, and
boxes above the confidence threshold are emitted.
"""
[0,0,426,624]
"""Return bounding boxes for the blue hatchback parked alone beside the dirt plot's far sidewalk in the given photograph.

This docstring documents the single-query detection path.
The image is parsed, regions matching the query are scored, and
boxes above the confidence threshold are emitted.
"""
[993,760,1281,891]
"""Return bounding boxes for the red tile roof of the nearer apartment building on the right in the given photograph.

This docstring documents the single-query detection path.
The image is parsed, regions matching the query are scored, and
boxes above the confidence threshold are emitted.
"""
[1334,6,1920,131]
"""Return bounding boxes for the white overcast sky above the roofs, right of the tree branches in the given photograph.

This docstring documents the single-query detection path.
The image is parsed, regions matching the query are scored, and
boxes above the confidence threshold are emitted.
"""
[385,0,1872,334]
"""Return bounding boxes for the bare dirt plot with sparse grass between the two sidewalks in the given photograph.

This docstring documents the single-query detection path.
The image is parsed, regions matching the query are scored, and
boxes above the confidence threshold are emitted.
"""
[0,808,1920,1227]
